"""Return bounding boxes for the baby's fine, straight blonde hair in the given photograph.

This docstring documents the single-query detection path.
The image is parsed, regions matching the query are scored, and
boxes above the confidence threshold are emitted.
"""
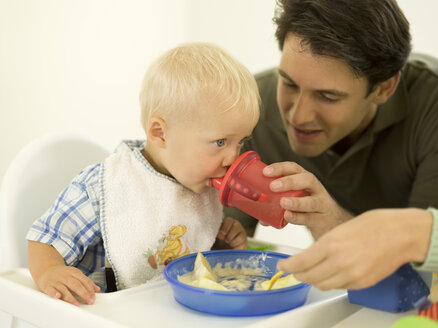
[140,42,260,131]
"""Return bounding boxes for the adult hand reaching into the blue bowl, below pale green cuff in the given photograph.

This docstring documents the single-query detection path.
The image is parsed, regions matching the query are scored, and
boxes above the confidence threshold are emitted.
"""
[278,209,433,290]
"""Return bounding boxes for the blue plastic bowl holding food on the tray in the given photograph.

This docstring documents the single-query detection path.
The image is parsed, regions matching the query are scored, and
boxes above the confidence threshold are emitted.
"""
[164,250,310,316]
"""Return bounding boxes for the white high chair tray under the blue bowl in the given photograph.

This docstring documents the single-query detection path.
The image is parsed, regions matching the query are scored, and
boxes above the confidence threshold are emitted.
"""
[0,241,361,328]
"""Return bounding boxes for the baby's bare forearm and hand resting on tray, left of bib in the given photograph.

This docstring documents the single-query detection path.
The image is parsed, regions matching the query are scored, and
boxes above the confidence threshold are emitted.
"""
[28,241,99,305]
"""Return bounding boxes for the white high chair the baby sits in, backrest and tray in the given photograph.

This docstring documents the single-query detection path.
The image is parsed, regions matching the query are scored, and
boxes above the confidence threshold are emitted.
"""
[0,135,366,328]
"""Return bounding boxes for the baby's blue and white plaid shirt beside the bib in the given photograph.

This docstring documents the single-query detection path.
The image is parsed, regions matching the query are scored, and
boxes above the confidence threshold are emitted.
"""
[26,164,105,289]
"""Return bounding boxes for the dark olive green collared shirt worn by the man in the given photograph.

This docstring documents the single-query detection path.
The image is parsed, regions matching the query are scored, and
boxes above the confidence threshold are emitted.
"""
[226,55,438,231]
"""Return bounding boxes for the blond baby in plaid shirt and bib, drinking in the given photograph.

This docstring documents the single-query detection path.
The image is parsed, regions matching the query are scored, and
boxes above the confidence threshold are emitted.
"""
[27,43,259,305]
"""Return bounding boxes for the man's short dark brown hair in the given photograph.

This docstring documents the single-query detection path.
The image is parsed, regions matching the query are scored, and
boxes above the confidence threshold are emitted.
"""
[273,0,411,92]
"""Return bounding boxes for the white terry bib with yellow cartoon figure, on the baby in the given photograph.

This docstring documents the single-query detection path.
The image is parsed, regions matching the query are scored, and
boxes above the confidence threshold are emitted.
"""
[100,147,222,289]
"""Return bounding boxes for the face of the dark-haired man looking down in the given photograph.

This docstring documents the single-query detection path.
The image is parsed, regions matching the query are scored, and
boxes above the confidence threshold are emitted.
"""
[277,34,377,157]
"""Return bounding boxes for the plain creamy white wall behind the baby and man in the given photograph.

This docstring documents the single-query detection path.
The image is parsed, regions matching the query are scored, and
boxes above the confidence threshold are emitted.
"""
[0,0,438,181]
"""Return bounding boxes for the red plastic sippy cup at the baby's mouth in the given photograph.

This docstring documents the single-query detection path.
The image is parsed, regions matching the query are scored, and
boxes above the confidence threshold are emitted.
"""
[210,151,305,229]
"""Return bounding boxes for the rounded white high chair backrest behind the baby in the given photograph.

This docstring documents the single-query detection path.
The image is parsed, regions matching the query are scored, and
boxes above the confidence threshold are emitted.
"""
[0,134,110,271]
